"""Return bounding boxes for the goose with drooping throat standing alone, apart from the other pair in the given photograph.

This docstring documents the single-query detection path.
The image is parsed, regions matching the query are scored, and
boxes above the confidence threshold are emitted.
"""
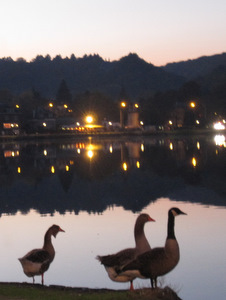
[19,225,65,285]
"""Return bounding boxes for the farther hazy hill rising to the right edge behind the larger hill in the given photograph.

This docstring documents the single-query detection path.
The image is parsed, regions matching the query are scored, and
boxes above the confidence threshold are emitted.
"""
[162,53,226,80]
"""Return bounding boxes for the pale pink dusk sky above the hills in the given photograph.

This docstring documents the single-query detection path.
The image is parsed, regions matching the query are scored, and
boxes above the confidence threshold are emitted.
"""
[0,0,226,66]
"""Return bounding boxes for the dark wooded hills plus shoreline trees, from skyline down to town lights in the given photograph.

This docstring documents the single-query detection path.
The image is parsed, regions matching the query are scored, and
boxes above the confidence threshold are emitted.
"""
[0,53,226,124]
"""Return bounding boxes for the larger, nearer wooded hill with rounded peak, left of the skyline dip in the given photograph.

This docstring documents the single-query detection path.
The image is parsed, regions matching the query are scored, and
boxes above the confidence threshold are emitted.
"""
[0,54,185,99]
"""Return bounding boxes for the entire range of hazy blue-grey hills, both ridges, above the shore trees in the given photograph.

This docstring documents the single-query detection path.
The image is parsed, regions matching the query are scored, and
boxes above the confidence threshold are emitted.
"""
[0,53,226,100]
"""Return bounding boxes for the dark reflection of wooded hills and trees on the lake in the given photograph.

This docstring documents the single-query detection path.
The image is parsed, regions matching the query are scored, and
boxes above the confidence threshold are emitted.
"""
[0,139,226,218]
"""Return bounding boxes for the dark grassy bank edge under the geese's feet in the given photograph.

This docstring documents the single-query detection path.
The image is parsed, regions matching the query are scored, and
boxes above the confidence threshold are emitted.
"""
[0,283,182,300]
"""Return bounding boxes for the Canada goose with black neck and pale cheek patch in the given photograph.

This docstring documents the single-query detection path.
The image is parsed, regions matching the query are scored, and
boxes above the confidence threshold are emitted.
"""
[122,207,186,288]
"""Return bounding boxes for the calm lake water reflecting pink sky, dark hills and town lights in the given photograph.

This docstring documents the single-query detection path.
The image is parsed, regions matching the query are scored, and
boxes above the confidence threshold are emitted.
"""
[0,134,226,300]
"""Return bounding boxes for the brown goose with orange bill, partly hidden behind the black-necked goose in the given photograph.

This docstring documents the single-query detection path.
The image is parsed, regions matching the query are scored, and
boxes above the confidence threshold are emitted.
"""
[97,214,155,290]
